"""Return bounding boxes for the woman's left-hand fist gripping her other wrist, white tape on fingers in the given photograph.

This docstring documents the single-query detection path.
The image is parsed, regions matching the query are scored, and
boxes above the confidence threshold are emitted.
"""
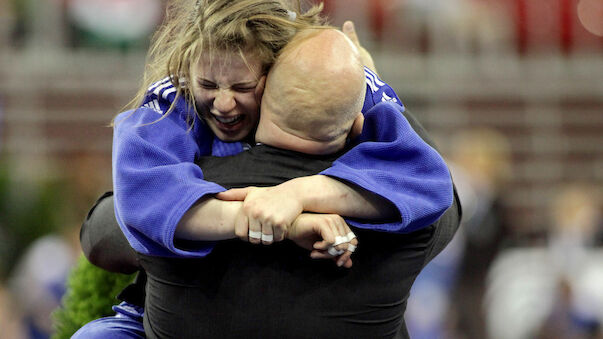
[216,185,303,245]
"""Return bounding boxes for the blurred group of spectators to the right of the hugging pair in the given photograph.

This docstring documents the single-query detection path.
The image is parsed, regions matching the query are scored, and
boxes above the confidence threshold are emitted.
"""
[407,129,603,339]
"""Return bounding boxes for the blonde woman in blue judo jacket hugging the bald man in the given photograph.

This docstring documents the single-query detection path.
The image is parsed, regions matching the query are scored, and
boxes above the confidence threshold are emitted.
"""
[74,0,452,337]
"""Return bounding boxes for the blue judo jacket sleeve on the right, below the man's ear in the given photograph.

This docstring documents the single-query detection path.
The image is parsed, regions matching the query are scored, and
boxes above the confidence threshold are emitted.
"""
[321,101,453,233]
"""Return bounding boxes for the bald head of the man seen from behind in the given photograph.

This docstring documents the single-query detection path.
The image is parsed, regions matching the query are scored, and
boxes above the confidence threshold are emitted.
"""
[257,29,366,153]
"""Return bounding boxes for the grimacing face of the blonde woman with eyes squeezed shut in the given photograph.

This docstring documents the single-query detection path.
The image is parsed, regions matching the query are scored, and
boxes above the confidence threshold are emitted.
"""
[191,52,266,141]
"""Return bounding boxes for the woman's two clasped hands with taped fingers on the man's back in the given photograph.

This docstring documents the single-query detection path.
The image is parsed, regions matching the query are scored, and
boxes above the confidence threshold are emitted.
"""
[216,186,358,268]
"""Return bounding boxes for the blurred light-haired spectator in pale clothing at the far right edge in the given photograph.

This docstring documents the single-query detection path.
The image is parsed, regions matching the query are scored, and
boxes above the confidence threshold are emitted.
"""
[540,184,603,338]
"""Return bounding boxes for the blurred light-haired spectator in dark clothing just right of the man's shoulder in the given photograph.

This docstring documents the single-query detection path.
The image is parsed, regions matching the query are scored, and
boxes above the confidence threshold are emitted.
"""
[450,128,511,338]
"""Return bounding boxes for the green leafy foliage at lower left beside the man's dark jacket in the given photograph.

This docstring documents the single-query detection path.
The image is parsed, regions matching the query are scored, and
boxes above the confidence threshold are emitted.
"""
[52,256,134,339]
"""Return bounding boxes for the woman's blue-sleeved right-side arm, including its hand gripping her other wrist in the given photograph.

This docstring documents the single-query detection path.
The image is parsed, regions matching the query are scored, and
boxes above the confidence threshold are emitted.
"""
[217,103,452,243]
